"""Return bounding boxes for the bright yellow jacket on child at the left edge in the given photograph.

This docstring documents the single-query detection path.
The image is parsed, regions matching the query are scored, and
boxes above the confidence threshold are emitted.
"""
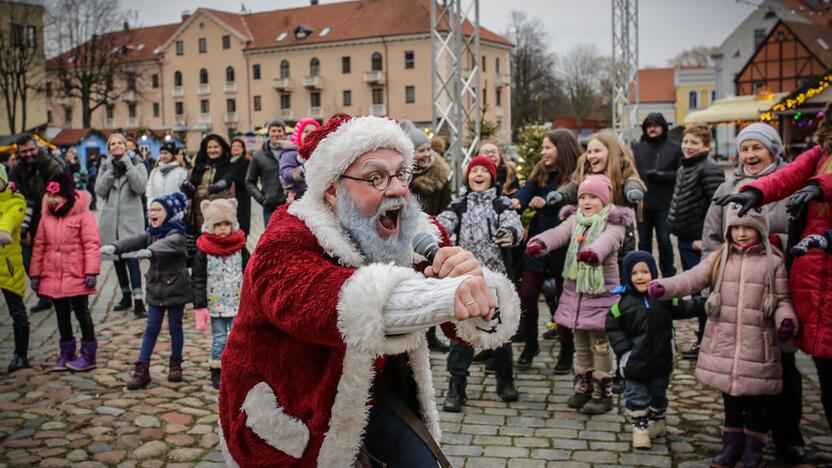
[0,189,26,296]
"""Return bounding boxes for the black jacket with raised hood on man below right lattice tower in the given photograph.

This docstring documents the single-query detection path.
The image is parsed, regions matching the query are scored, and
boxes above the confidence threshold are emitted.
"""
[633,112,682,210]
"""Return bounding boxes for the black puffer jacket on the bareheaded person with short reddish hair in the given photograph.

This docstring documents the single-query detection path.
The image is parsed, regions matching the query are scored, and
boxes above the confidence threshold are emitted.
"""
[667,152,725,240]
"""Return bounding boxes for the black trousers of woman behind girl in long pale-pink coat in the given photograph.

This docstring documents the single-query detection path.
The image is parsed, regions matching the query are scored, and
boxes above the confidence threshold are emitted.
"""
[769,353,806,448]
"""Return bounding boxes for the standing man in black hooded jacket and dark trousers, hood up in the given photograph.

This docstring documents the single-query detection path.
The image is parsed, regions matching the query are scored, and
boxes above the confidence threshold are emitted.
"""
[633,112,682,277]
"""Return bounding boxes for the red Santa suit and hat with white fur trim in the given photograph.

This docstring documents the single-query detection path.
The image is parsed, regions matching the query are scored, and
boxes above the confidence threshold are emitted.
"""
[219,117,519,467]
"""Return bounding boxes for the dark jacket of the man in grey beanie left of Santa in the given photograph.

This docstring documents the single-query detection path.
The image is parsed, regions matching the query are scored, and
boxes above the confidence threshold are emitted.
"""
[246,141,297,211]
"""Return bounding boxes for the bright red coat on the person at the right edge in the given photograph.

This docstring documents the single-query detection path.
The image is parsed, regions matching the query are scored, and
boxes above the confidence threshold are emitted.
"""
[740,146,832,359]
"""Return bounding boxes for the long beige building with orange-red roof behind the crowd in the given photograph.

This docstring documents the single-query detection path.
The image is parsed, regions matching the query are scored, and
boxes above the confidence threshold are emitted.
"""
[50,0,512,150]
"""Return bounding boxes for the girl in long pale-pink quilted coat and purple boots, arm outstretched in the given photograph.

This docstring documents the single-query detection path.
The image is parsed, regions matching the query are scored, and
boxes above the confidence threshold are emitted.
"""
[648,203,797,467]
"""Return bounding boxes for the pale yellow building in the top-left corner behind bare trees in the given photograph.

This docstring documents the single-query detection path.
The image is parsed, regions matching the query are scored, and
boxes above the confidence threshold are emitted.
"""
[0,1,47,135]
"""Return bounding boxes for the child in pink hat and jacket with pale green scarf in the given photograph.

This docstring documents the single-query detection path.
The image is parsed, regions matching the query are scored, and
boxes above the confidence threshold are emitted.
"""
[526,174,634,414]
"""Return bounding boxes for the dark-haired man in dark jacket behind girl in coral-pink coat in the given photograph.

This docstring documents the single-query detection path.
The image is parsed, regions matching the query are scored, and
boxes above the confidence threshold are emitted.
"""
[9,133,63,312]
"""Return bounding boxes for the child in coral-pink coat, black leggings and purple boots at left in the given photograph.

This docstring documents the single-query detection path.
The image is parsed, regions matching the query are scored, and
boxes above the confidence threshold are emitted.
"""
[29,173,101,372]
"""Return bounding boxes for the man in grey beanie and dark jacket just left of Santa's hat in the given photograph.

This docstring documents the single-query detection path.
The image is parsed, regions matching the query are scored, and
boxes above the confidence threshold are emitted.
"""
[246,119,297,227]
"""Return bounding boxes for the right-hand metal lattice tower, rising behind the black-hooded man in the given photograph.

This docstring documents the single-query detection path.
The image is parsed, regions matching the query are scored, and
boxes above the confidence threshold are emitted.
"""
[612,0,639,143]
